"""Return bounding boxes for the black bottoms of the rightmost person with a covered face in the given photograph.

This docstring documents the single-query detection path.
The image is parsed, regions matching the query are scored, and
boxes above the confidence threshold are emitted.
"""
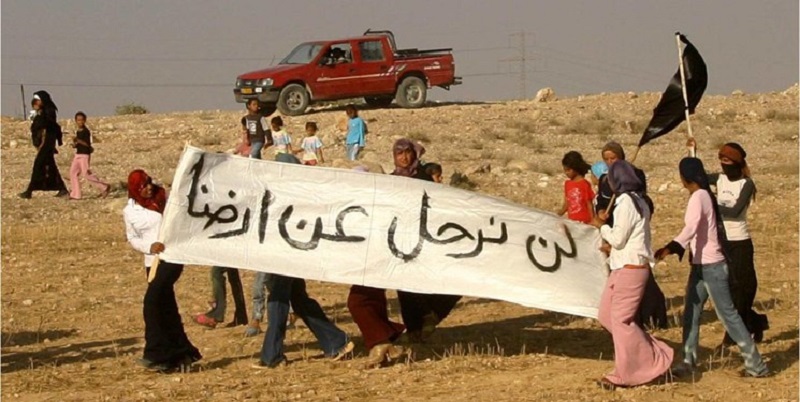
[723,239,769,342]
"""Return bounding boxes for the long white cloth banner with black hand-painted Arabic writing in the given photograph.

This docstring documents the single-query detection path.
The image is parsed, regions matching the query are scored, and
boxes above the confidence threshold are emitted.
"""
[160,147,607,317]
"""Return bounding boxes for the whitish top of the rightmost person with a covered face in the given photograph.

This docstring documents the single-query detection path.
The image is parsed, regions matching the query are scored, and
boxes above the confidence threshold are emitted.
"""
[717,174,753,240]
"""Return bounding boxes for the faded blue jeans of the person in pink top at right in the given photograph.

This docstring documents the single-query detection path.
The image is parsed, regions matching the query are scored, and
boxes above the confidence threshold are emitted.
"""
[683,261,767,375]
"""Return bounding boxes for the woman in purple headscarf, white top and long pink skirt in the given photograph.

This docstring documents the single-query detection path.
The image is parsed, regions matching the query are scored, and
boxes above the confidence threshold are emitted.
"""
[593,160,673,389]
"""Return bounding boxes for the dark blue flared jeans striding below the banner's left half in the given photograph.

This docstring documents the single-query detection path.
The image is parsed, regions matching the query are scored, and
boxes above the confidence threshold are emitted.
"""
[261,274,348,366]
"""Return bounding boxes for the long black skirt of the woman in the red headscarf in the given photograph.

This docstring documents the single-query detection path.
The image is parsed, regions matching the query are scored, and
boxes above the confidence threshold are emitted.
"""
[144,261,202,366]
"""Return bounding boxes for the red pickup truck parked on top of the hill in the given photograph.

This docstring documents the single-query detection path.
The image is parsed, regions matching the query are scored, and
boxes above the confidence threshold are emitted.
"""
[233,30,461,116]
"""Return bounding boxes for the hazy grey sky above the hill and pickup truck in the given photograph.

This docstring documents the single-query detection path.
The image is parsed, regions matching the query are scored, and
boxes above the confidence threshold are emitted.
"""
[0,0,798,117]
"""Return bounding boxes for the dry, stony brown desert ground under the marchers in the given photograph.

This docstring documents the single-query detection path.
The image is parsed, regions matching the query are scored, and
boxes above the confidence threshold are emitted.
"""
[0,84,800,402]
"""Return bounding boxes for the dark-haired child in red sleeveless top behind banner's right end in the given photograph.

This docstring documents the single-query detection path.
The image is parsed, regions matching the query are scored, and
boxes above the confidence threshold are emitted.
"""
[558,151,594,223]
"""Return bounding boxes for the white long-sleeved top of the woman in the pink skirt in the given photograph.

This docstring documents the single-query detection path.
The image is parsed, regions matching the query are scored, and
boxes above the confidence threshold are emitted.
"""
[600,194,655,270]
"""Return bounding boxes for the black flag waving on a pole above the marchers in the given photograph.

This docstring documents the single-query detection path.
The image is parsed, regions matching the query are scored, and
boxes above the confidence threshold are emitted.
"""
[639,35,708,147]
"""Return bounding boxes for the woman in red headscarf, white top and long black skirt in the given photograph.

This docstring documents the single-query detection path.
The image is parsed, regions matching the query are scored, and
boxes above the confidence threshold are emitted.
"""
[122,170,202,372]
